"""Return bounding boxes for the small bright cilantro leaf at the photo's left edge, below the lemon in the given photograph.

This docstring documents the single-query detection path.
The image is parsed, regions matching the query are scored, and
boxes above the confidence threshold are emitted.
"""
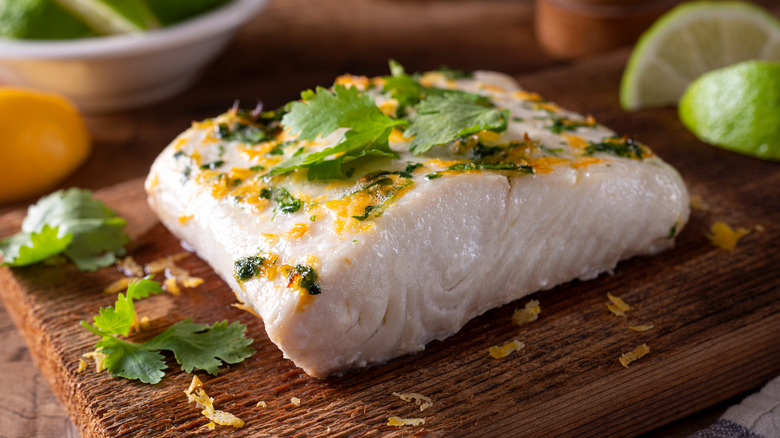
[0,224,73,266]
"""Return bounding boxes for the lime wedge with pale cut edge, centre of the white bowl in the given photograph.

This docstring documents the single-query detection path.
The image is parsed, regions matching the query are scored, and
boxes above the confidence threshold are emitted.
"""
[54,0,158,35]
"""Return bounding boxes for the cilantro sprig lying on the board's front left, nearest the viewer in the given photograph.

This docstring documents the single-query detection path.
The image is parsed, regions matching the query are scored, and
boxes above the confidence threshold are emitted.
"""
[81,276,255,384]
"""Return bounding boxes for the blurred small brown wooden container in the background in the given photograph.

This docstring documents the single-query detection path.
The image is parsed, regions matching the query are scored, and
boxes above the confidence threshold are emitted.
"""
[535,0,681,59]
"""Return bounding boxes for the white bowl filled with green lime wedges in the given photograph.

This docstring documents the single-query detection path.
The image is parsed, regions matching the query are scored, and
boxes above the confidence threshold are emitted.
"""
[0,0,269,113]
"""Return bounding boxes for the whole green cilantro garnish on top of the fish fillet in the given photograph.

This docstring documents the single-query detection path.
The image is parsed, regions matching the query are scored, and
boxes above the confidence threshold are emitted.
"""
[269,60,509,180]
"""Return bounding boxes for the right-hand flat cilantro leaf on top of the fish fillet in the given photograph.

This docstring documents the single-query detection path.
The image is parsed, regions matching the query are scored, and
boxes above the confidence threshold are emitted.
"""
[404,93,509,155]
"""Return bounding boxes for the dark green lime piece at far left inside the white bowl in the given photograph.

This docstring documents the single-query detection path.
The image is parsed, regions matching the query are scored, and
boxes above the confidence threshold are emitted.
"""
[0,0,95,40]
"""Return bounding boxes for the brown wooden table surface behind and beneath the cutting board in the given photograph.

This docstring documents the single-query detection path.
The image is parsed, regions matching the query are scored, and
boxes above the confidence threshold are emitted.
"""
[0,0,780,437]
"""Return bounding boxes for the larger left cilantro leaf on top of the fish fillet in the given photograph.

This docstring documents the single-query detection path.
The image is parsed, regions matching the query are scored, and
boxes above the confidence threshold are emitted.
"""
[271,85,407,179]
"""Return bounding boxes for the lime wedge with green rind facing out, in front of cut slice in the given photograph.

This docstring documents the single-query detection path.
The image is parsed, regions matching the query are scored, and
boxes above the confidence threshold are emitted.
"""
[678,61,780,160]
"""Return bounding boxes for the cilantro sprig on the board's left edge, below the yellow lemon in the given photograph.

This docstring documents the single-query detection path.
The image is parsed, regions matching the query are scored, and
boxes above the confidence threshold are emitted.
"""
[0,188,130,271]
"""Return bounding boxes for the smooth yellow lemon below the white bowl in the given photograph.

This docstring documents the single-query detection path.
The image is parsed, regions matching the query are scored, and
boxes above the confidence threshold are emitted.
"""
[0,87,92,203]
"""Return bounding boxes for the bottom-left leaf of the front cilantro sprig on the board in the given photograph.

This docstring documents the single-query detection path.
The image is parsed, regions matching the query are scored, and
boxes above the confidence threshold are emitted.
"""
[96,336,168,384]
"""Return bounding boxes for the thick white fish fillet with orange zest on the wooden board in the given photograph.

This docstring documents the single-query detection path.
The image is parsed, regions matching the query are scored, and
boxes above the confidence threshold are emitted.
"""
[146,72,689,377]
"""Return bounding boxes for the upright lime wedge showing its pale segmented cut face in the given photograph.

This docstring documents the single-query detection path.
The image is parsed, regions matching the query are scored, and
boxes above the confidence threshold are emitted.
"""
[620,1,780,110]
